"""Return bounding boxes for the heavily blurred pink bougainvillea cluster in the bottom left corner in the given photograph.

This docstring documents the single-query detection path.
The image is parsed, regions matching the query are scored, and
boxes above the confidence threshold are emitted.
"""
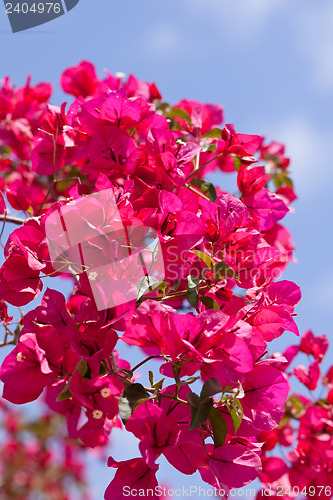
[0,401,89,500]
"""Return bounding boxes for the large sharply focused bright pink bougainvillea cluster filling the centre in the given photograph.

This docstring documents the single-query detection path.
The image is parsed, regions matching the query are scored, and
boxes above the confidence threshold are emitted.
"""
[0,62,304,500]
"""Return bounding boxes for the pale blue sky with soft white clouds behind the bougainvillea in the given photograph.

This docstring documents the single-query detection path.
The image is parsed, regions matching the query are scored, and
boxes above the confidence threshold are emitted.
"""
[0,0,333,500]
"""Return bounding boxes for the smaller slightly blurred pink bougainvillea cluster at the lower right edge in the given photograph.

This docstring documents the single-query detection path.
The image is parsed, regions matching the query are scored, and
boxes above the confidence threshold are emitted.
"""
[258,330,333,499]
